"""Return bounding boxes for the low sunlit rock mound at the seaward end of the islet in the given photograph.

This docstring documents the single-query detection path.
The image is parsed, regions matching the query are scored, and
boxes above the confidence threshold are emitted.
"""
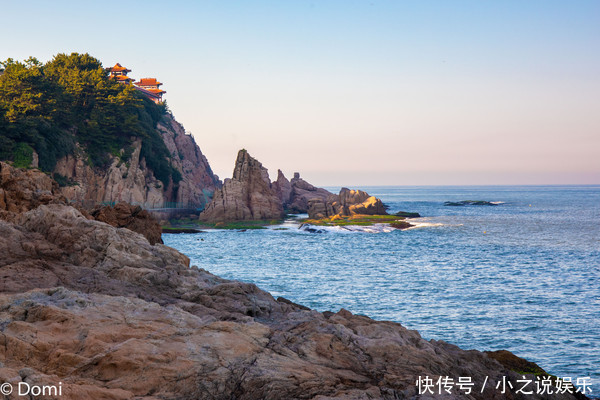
[308,188,387,219]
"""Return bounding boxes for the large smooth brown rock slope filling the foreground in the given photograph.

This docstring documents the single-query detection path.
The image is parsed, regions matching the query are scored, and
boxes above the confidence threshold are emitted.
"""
[0,164,575,400]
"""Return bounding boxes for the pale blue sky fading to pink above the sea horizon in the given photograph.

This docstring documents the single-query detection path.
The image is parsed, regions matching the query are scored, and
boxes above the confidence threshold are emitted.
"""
[0,0,600,186]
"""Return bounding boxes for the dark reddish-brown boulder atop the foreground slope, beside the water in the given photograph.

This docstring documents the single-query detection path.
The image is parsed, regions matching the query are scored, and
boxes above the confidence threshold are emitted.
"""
[91,203,163,244]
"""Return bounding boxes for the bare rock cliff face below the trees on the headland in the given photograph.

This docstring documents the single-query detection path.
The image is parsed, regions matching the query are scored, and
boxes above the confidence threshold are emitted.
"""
[54,114,220,208]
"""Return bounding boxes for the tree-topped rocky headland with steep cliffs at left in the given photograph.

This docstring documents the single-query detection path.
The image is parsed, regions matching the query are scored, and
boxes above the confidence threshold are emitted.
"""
[0,53,221,211]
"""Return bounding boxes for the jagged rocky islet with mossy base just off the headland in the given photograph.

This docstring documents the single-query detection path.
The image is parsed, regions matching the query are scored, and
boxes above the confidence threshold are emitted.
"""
[199,149,412,229]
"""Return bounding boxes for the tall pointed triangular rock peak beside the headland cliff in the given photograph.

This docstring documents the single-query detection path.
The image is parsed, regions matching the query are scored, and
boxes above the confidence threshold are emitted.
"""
[200,150,283,222]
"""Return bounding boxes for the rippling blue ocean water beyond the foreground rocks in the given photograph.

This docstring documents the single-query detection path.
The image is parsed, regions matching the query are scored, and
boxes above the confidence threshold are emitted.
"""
[163,186,600,395]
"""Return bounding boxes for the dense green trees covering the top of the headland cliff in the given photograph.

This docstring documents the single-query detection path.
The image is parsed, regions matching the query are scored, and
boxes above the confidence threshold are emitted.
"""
[0,53,181,185]
